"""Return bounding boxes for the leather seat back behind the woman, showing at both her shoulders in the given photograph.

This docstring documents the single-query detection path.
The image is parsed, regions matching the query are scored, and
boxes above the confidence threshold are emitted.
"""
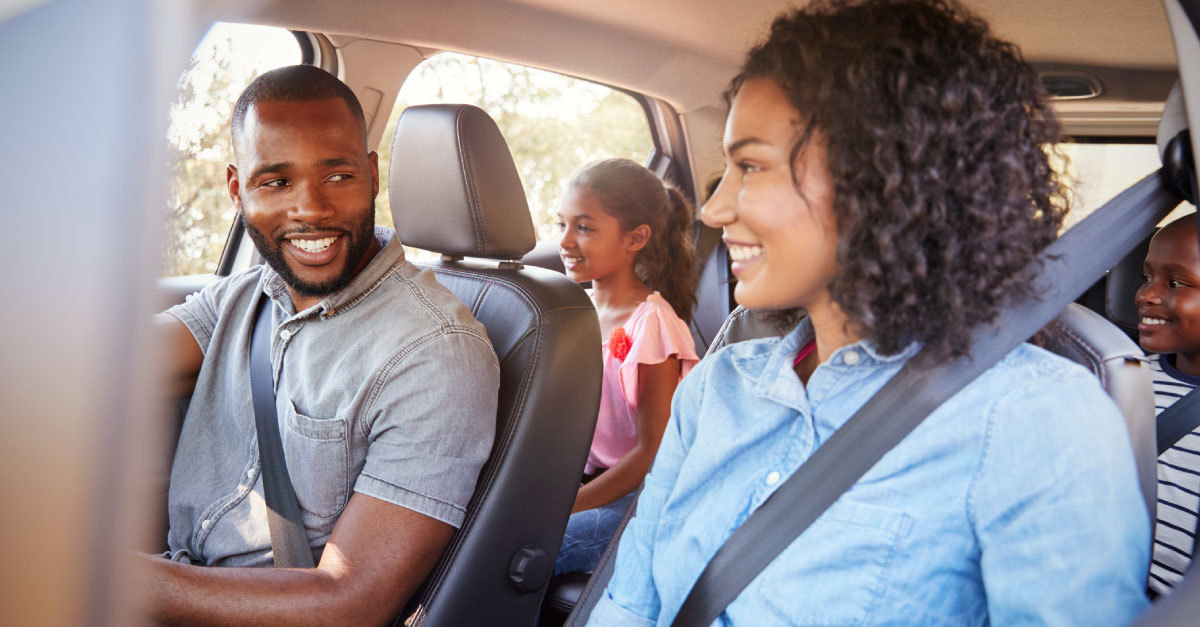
[709,302,1158,519]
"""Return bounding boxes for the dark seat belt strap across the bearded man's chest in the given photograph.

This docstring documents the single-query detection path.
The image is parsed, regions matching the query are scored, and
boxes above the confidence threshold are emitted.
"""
[250,294,313,568]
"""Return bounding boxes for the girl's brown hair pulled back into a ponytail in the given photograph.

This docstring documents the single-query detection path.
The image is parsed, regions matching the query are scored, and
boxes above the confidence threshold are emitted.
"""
[566,159,696,322]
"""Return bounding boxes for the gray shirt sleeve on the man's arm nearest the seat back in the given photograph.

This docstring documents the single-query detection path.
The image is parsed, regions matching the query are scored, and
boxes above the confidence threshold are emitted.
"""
[354,332,499,527]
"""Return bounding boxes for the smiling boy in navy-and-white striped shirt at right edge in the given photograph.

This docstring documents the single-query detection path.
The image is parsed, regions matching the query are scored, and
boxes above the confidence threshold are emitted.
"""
[1135,215,1200,593]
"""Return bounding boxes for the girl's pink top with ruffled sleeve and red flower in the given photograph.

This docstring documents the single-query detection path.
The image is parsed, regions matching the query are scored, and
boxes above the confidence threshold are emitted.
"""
[584,292,697,473]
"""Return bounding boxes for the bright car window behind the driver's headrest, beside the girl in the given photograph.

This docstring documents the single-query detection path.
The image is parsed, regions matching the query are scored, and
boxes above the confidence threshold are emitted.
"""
[376,53,654,246]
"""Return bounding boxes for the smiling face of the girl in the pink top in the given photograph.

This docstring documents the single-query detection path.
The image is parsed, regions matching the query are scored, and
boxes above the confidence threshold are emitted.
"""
[558,189,641,282]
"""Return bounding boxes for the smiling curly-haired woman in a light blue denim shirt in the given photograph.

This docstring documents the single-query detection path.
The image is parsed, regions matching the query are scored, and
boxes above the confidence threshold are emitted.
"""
[590,0,1150,625]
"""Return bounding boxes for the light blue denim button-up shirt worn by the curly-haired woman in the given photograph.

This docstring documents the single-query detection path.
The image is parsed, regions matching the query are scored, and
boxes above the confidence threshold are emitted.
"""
[588,322,1150,626]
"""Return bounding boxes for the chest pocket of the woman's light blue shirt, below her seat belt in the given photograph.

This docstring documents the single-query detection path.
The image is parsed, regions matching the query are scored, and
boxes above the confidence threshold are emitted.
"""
[748,501,912,625]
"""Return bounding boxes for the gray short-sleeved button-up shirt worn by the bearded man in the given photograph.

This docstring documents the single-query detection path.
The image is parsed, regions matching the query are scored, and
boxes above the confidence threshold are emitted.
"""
[167,229,499,566]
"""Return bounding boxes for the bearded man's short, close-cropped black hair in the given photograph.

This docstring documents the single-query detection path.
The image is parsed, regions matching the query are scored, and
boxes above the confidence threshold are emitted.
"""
[232,65,367,153]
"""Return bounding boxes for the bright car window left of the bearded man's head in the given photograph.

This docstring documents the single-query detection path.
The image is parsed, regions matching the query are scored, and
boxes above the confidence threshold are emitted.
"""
[162,23,301,276]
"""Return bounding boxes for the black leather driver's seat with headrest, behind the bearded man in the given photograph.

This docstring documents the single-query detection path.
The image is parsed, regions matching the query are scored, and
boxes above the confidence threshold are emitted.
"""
[389,105,602,626]
